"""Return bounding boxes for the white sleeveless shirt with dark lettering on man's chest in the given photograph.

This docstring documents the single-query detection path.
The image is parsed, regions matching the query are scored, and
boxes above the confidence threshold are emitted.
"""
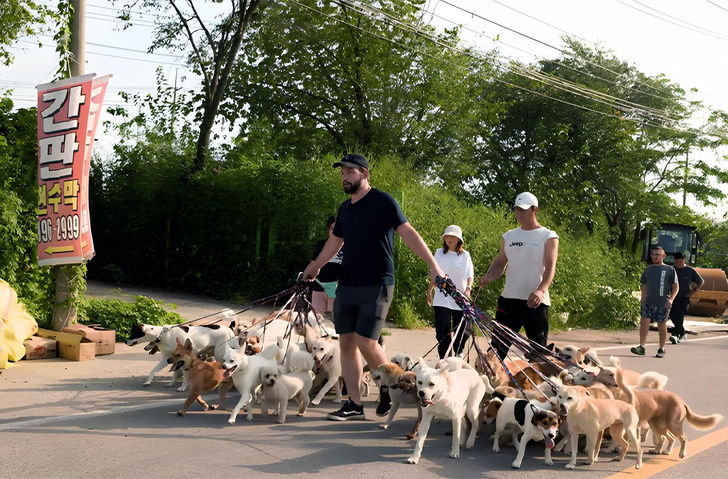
[502,226,559,306]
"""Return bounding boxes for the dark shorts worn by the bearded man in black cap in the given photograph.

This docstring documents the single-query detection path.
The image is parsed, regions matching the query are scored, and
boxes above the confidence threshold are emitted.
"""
[334,284,394,340]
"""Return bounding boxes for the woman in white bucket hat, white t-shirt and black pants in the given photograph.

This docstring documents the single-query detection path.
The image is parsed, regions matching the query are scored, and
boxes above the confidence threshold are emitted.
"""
[427,225,473,359]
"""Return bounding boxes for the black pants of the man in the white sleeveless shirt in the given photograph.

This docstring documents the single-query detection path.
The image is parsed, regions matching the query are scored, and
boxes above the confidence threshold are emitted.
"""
[493,296,549,358]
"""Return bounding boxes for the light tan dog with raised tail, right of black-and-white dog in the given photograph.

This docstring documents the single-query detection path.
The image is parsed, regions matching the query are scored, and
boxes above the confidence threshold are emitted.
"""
[556,370,642,469]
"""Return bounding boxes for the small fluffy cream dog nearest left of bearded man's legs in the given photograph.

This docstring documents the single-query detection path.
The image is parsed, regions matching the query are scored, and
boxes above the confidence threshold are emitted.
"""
[260,362,313,424]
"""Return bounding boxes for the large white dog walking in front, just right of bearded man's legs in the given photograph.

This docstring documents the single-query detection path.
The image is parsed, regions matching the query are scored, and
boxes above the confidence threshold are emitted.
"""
[407,358,485,464]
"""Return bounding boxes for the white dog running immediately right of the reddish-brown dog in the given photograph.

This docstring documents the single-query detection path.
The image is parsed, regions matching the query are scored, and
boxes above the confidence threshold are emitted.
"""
[222,339,278,424]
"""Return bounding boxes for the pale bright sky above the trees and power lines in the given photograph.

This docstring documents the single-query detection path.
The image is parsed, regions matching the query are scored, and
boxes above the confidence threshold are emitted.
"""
[0,0,728,218]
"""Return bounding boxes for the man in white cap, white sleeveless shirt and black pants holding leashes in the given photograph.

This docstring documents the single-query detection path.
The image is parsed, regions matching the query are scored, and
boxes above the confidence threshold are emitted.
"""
[480,193,559,358]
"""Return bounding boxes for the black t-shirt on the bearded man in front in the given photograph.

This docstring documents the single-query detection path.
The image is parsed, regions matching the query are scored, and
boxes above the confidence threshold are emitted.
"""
[334,188,407,286]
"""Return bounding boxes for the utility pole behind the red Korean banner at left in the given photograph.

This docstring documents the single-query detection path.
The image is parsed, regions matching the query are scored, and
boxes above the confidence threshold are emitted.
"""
[53,0,86,331]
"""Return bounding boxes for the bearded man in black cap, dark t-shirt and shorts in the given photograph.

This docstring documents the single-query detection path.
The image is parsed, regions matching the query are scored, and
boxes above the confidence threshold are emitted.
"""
[303,153,445,421]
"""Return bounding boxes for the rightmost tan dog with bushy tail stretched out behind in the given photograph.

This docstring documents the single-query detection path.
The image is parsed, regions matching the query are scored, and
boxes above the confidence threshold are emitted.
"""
[617,360,723,459]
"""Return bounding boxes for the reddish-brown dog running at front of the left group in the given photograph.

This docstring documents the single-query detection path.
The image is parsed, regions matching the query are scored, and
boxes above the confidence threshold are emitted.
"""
[167,338,232,416]
